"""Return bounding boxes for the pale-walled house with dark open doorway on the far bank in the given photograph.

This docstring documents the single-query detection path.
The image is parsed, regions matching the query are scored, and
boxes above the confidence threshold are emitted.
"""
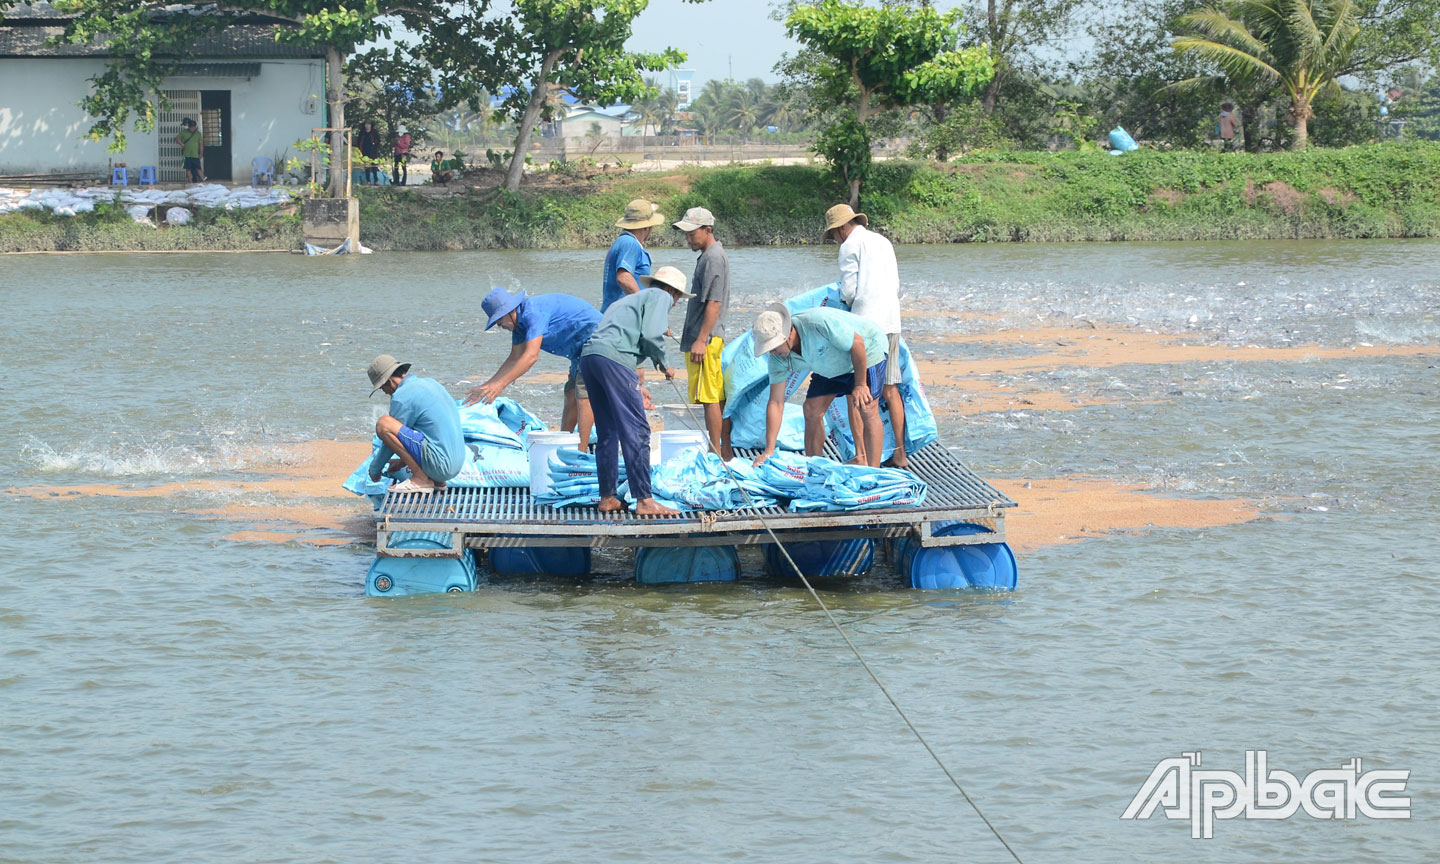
[0,3,327,183]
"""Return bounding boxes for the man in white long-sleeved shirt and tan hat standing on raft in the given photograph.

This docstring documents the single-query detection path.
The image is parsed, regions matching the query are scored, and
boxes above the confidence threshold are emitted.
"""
[825,204,910,468]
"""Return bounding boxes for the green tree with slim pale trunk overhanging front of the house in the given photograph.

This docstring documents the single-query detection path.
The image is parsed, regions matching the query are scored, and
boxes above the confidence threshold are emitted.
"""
[45,0,423,196]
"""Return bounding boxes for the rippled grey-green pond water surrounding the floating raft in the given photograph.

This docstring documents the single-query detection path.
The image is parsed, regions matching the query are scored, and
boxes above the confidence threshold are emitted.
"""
[0,242,1440,864]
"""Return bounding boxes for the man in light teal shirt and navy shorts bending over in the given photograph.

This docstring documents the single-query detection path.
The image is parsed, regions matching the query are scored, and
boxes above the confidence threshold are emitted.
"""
[753,302,886,468]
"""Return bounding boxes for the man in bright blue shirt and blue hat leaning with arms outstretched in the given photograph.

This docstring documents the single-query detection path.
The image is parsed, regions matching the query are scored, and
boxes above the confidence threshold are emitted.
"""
[465,288,600,452]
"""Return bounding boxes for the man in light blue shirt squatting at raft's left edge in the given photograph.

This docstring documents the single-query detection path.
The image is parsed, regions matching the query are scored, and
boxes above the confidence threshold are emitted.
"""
[367,354,465,494]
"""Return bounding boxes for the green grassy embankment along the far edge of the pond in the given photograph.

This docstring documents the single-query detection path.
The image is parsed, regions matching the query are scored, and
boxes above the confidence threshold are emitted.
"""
[0,141,1440,251]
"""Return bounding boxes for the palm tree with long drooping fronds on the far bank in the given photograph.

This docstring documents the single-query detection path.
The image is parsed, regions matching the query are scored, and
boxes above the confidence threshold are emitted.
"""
[1171,0,1359,150]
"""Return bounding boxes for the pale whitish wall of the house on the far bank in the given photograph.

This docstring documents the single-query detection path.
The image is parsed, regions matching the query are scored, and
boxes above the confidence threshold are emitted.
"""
[0,58,325,181]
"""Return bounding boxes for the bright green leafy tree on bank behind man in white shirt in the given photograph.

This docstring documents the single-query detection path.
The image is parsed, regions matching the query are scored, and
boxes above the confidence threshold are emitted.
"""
[785,0,995,207]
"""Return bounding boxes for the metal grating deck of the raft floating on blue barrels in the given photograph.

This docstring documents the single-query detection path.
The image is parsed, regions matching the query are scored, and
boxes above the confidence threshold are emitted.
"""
[376,444,1015,557]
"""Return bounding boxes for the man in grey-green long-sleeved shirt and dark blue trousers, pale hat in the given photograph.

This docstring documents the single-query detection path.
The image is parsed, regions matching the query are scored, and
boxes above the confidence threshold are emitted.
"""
[580,266,694,516]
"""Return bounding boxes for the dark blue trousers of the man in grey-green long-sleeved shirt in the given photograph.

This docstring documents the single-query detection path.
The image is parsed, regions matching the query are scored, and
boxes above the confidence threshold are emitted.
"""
[580,354,651,501]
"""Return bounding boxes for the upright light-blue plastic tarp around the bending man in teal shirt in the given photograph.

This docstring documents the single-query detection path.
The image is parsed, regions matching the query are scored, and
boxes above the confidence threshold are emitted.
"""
[721,282,939,459]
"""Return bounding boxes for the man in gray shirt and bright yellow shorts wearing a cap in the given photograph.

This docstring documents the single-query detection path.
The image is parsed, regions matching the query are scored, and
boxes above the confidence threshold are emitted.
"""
[675,207,734,461]
